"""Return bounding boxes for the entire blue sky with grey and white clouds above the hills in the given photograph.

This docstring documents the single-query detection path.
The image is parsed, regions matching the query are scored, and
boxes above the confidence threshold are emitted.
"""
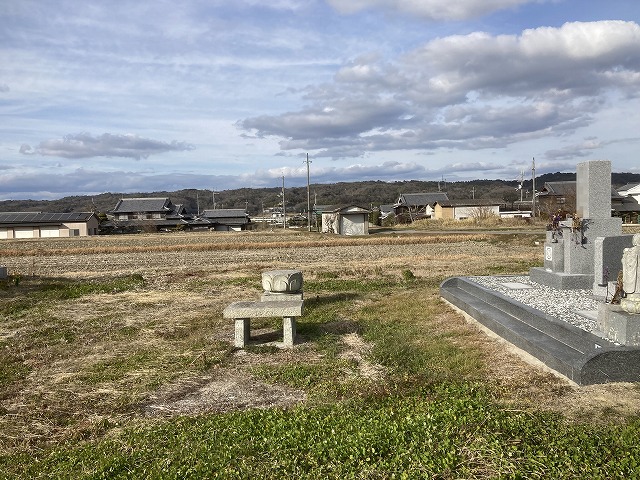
[0,0,640,199]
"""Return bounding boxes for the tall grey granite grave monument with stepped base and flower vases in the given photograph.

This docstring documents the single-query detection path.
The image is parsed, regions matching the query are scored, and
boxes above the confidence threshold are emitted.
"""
[529,160,631,293]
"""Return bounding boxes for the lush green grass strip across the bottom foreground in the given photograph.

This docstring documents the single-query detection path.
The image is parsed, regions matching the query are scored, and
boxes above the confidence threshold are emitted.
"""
[0,384,640,479]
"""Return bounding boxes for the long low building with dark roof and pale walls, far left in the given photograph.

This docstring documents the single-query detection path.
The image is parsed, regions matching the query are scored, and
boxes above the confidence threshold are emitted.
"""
[0,212,100,239]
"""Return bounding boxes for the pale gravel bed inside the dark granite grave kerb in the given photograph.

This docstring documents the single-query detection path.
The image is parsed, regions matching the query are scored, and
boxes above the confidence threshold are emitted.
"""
[468,275,602,333]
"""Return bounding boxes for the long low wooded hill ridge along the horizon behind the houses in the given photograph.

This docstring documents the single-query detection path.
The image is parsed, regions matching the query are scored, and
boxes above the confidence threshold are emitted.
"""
[0,172,640,215]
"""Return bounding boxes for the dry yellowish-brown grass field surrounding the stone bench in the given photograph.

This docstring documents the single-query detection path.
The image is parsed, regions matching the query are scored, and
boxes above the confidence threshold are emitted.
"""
[0,231,640,476]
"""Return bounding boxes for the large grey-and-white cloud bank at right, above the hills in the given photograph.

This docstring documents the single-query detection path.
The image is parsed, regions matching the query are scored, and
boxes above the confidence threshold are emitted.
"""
[239,21,640,158]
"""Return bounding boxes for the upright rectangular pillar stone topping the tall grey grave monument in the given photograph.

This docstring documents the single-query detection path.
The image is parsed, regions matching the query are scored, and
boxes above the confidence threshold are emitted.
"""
[576,160,611,218]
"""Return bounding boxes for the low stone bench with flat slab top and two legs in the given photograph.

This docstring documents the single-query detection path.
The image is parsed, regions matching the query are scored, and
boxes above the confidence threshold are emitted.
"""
[222,300,303,348]
